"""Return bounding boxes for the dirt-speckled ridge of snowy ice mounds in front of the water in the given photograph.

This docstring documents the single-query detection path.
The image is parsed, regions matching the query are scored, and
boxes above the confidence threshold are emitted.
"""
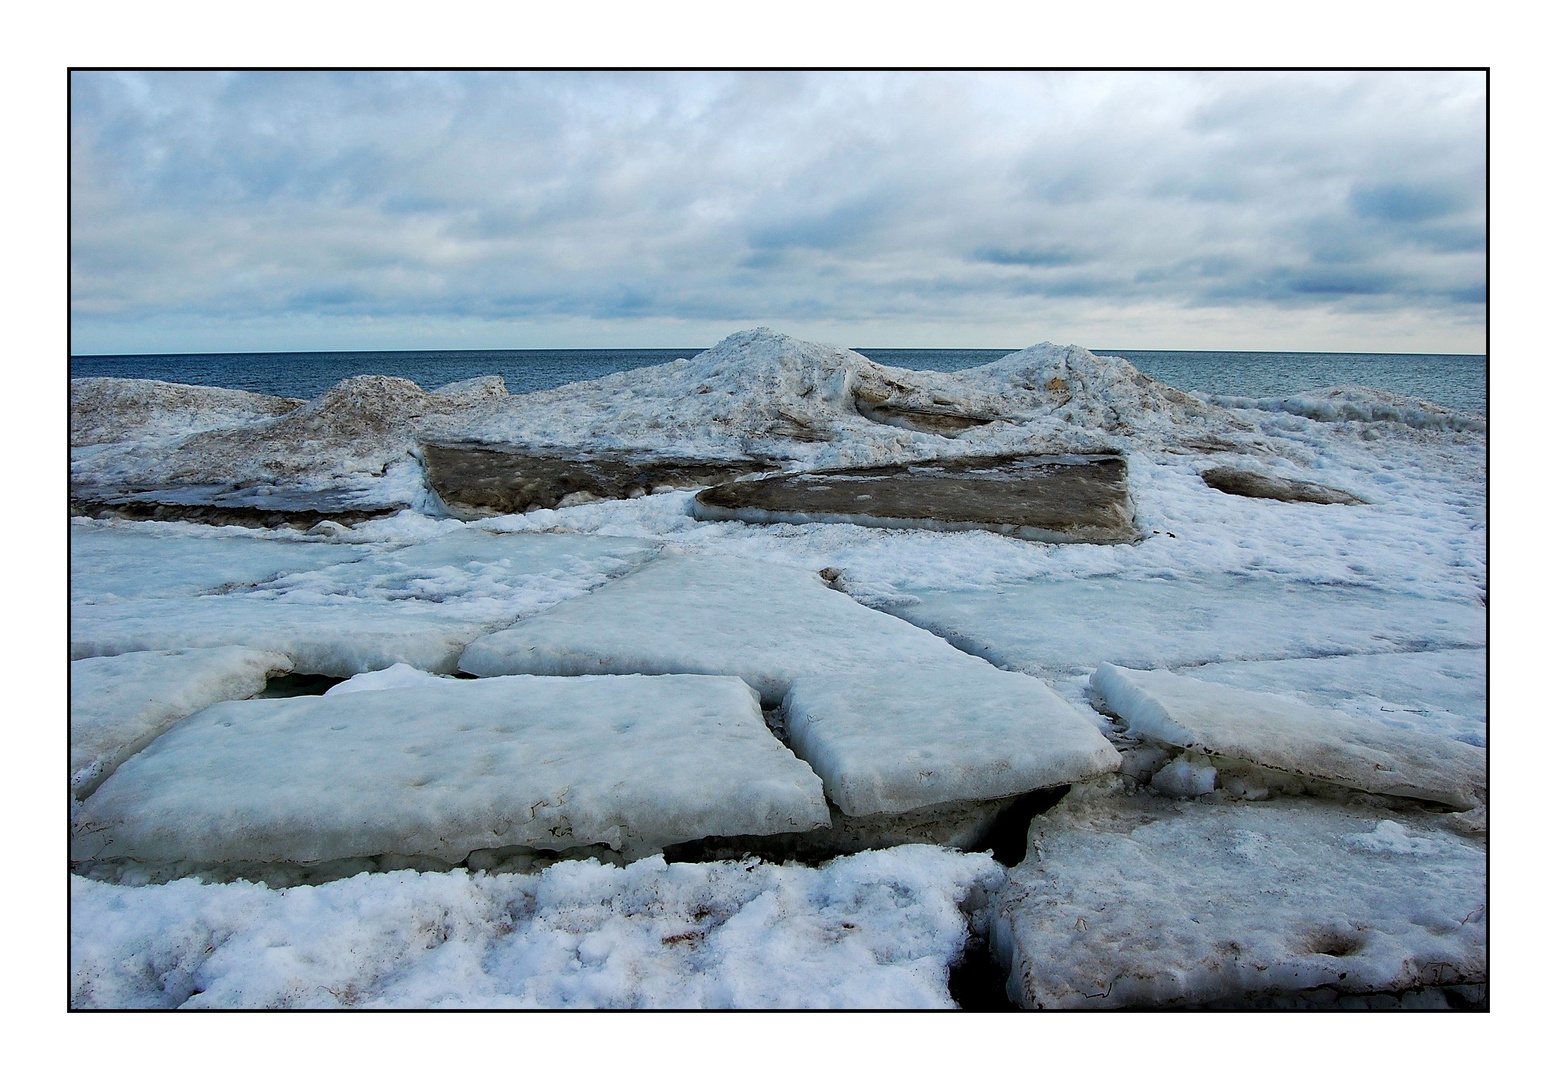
[72,328,1252,512]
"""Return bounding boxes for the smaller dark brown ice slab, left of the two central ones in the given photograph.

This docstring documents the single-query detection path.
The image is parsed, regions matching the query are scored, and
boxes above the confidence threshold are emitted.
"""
[422,442,775,517]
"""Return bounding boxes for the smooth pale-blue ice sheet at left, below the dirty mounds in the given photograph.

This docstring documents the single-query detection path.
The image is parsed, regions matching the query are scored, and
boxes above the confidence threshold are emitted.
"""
[72,515,657,675]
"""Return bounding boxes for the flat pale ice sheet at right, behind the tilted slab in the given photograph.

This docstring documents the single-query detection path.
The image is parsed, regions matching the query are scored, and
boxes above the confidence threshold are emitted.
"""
[892,574,1487,675]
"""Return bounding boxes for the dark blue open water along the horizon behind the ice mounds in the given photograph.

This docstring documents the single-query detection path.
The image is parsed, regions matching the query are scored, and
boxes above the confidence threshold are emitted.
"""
[70,347,1487,416]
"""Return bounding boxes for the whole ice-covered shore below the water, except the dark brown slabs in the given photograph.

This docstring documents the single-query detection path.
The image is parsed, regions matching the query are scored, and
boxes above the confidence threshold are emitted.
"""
[70,330,1487,1008]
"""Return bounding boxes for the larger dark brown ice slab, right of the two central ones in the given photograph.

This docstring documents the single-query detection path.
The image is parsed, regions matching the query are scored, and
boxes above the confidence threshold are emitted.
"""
[693,454,1140,543]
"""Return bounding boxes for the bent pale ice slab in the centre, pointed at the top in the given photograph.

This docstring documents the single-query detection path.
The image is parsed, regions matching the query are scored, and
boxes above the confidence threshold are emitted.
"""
[459,556,1118,814]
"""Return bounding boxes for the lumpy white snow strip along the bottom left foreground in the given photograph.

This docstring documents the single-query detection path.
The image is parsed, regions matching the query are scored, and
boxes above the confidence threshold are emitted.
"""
[70,845,1003,1008]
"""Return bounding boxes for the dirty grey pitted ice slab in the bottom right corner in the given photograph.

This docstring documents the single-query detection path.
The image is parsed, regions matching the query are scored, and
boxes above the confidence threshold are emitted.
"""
[992,797,1487,1008]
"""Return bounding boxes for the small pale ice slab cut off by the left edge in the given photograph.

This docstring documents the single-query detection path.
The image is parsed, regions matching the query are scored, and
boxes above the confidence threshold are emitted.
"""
[70,647,291,798]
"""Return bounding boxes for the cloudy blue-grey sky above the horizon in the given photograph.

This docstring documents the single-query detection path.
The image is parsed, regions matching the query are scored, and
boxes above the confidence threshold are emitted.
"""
[70,72,1487,353]
